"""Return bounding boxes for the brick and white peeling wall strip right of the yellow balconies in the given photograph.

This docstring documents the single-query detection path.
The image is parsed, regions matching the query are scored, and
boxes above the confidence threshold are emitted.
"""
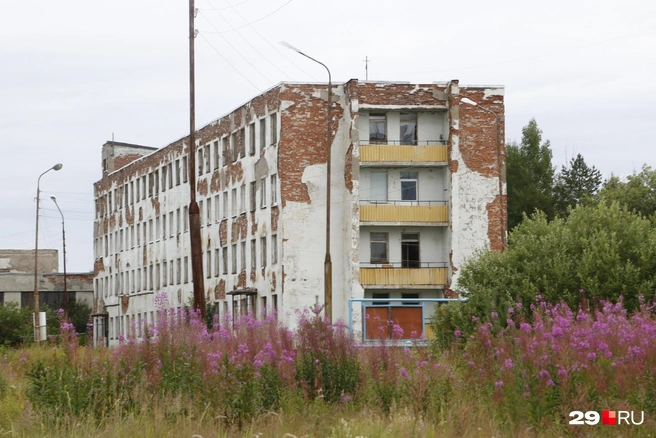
[449,81,507,290]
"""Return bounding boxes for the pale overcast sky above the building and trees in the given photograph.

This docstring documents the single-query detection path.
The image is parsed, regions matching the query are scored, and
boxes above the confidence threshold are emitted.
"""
[0,0,656,272]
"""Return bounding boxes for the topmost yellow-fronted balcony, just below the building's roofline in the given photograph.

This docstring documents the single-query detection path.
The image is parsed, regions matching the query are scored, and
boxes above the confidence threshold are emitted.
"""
[360,140,449,166]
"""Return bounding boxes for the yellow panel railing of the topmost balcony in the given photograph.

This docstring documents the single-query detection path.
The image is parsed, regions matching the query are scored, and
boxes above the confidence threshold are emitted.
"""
[360,142,448,163]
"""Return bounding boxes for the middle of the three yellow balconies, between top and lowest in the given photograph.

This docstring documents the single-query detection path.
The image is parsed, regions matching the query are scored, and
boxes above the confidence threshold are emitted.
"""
[360,201,449,225]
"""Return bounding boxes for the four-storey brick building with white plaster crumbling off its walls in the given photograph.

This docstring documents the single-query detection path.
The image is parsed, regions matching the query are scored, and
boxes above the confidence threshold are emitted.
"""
[94,80,506,345]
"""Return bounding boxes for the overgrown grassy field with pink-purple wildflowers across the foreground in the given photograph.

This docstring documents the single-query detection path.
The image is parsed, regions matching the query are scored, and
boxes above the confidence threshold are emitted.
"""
[0,296,656,437]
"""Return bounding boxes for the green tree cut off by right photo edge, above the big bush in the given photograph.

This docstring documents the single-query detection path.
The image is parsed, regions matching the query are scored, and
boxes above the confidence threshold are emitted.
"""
[599,164,656,217]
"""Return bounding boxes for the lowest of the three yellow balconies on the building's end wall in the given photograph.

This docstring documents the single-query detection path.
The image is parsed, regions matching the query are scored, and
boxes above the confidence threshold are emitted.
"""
[360,262,448,288]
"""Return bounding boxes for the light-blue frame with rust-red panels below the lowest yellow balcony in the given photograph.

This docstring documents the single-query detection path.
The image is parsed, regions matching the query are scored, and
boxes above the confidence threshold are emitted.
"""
[349,298,461,344]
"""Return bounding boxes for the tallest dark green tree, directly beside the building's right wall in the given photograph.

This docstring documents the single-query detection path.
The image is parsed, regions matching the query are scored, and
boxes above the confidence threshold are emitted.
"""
[506,119,554,230]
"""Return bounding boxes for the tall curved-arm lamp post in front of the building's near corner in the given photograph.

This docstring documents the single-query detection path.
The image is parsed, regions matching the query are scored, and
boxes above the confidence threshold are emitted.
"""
[280,41,333,321]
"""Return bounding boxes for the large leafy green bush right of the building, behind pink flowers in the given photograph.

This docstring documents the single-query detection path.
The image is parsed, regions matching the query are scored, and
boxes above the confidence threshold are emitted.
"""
[433,202,656,350]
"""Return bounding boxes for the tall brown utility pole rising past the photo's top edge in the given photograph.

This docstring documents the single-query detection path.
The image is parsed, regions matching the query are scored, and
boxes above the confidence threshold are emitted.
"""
[187,0,206,321]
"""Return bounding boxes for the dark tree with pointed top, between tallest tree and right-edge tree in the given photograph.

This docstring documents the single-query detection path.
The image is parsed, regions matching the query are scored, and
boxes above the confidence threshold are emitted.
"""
[554,154,601,217]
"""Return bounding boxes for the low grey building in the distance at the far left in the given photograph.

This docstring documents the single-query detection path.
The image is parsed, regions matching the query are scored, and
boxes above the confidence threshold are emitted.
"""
[0,249,93,309]
